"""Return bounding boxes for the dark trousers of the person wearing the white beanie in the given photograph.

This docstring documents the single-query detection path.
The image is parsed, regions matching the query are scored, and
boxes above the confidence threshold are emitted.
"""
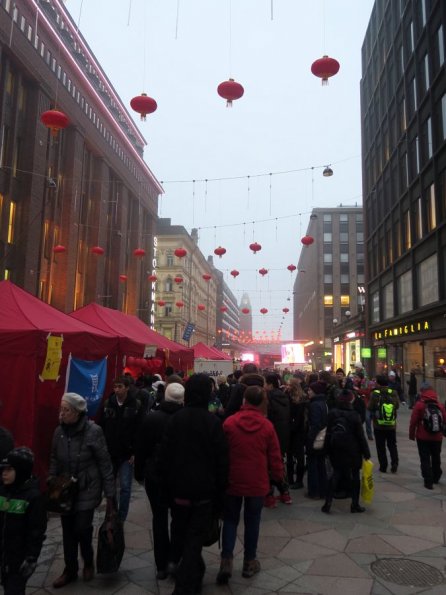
[145,480,175,570]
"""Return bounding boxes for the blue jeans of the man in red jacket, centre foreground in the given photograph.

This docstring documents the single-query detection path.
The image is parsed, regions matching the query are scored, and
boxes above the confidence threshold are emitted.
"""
[221,495,263,560]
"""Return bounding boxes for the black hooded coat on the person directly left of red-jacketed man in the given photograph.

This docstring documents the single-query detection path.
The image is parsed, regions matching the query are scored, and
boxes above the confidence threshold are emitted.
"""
[159,405,229,502]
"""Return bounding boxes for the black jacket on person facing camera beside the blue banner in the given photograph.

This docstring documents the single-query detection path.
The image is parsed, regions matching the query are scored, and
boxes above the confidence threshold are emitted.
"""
[98,392,144,463]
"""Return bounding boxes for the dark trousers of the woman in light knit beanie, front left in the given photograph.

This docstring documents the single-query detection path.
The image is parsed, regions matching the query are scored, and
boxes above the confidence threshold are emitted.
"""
[60,509,94,575]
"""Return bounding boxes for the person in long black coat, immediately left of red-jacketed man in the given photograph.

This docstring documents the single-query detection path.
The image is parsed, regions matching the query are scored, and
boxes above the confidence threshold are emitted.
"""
[159,374,229,595]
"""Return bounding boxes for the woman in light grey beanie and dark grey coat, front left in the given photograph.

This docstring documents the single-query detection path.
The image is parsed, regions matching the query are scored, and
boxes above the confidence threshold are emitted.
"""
[48,393,115,589]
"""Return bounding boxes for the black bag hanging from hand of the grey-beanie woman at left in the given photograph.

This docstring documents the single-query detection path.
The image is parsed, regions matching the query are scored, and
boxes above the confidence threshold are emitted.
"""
[96,515,125,574]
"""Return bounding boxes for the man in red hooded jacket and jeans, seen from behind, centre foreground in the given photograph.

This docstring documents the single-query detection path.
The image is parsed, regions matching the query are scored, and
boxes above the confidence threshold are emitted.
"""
[217,386,284,585]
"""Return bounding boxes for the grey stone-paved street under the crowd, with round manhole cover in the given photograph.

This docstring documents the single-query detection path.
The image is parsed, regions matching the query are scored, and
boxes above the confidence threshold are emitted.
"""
[27,408,446,595]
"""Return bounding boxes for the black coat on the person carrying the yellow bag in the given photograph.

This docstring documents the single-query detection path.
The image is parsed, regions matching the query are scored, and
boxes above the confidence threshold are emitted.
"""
[324,403,370,470]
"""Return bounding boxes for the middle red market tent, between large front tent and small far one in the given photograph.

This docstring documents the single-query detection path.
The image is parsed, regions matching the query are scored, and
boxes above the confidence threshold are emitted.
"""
[70,304,194,372]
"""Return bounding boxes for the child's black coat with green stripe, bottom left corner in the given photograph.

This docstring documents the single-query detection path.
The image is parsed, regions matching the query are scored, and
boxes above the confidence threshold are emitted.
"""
[0,477,47,573]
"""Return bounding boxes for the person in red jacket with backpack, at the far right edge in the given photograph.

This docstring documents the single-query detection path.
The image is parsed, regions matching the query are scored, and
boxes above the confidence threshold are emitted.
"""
[409,382,446,490]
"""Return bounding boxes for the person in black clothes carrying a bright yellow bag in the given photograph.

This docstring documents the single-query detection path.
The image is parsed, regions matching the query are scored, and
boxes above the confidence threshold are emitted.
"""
[322,389,370,514]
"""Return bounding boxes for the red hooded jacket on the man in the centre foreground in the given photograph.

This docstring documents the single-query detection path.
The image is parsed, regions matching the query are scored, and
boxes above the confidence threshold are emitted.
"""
[223,404,284,496]
